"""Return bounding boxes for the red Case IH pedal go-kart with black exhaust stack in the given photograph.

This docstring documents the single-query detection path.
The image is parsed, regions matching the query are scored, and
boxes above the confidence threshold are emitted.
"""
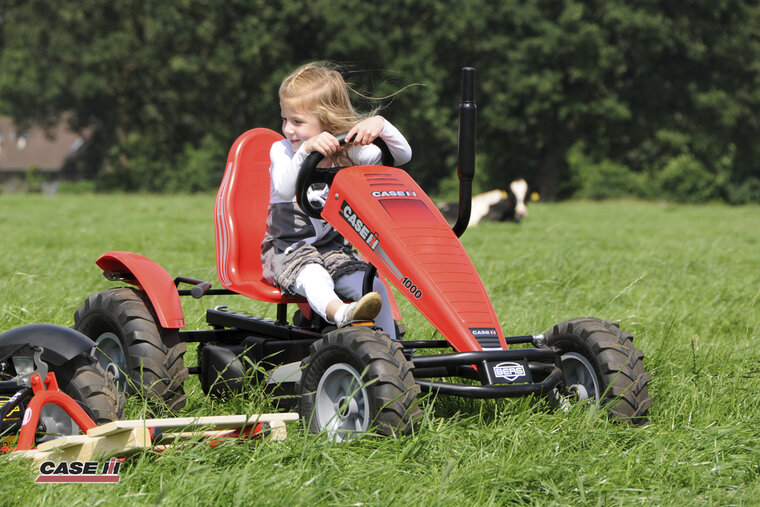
[75,68,651,440]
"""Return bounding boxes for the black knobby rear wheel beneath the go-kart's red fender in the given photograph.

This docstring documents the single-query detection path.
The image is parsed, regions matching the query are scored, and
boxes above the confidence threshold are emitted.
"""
[74,288,188,410]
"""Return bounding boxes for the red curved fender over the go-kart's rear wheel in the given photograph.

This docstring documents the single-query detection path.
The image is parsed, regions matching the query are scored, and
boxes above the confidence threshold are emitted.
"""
[95,252,185,329]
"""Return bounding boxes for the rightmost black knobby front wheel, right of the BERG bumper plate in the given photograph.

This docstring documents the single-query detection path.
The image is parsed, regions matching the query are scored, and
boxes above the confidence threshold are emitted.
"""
[545,318,652,425]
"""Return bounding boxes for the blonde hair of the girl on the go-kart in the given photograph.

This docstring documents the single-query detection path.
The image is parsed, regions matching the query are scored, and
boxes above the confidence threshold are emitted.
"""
[279,62,366,135]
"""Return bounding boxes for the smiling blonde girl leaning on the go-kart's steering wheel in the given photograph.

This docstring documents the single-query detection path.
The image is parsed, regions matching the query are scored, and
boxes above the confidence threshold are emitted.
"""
[261,62,412,339]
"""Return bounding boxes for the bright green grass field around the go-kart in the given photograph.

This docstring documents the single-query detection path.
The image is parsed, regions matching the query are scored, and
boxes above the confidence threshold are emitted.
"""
[0,195,760,505]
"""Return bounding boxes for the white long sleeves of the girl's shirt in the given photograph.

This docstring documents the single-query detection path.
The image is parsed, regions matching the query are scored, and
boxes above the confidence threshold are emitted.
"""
[269,120,412,204]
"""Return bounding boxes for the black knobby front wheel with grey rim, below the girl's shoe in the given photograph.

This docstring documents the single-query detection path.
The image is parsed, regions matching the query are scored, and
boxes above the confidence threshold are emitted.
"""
[296,327,421,442]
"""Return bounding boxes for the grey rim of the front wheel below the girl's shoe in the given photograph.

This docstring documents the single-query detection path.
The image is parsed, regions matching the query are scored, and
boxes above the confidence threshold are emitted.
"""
[315,363,370,442]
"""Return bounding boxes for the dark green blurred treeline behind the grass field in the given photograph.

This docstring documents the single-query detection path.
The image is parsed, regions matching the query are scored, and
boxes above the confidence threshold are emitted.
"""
[0,0,760,203]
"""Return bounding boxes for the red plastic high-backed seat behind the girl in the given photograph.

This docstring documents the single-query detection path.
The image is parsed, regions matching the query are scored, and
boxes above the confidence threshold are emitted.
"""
[214,128,304,303]
